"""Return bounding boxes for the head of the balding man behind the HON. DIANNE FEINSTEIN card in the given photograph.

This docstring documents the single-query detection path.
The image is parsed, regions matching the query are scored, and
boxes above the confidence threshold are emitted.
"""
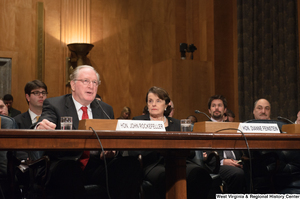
[253,99,271,120]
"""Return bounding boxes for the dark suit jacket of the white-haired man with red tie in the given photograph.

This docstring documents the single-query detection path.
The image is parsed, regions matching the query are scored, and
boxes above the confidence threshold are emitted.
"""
[38,94,114,160]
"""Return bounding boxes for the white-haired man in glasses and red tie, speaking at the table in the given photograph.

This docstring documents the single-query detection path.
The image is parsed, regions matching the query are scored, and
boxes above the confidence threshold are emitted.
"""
[36,65,140,199]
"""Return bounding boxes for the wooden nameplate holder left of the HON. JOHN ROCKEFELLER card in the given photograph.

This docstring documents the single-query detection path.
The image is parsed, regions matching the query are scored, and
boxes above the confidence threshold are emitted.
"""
[78,119,118,131]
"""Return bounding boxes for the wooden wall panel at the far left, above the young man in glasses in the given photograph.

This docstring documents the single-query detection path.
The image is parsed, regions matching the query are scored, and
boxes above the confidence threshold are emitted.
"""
[0,0,36,111]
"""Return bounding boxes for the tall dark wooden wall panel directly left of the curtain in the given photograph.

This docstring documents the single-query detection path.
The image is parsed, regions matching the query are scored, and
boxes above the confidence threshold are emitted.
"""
[214,0,238,119]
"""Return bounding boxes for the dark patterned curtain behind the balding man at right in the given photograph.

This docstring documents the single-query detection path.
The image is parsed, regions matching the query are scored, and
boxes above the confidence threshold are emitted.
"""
[237,0,300,121]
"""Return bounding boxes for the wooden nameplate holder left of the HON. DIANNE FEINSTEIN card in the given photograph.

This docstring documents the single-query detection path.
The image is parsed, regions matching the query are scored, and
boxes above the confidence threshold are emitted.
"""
[193,121,240,133]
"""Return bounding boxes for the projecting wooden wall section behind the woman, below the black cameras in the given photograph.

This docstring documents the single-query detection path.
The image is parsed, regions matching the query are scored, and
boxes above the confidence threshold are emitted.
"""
[153,59,213,121]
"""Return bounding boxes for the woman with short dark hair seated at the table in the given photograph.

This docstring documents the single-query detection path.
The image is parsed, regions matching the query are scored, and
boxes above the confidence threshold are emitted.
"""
[129,86,212,199]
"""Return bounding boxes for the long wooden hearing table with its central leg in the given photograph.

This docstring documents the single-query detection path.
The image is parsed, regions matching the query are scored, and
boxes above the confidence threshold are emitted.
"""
[0,129,300,199]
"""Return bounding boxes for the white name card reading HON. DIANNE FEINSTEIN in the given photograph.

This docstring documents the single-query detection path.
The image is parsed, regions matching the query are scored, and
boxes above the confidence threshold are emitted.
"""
[238,123,280,133]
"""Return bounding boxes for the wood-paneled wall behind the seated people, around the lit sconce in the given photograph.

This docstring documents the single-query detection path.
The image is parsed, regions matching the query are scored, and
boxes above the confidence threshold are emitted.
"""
[0,0,237,120]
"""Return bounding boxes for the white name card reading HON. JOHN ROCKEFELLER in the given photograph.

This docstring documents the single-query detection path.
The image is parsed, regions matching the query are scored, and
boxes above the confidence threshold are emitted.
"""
[116,120,166,131]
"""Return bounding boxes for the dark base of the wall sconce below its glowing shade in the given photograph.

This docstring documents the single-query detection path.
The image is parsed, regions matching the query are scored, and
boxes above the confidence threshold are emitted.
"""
[66,43,94,86]
